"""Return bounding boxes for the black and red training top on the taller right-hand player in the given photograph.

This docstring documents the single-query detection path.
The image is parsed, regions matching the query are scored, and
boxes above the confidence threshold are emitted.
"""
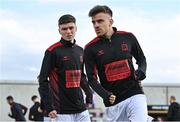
[84,27,146,106]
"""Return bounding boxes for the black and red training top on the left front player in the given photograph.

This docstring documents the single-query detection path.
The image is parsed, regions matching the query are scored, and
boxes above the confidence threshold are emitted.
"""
[39,39,92,114]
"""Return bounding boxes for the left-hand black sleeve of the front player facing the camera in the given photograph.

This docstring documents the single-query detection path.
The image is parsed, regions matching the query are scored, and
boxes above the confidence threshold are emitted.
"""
[38,50,53,113]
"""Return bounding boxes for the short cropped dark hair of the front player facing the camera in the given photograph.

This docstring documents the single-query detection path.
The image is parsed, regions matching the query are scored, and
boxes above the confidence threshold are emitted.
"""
[58,14,76,25]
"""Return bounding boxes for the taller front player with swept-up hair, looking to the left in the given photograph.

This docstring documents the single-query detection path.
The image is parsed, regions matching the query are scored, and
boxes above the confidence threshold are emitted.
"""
[84,5,147,122]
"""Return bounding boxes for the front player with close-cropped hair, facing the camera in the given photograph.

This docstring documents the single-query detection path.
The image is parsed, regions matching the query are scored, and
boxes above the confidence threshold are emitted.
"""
[39,14,92,121]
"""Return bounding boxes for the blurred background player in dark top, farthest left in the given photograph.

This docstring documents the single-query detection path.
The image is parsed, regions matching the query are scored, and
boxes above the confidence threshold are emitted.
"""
[6,96,27,121]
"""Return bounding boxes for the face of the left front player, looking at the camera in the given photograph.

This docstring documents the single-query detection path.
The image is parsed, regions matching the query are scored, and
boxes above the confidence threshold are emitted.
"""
[59,22,77,41]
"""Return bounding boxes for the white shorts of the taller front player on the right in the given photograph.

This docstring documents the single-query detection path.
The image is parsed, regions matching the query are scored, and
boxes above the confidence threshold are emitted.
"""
[106,94,148,122]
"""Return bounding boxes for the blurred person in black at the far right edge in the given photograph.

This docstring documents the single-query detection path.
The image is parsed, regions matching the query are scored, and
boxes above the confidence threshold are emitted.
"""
[167,96,180,121]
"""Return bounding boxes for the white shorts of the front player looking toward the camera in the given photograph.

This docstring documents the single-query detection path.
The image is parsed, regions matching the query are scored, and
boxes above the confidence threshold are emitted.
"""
[44,110,91,122]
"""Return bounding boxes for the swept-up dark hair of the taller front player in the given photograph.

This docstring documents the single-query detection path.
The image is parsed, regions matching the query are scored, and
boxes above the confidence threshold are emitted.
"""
[88,5,113,17]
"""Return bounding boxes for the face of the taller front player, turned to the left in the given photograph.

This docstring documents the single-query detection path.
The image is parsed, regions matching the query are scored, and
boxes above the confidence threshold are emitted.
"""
[92,13,113,36]
